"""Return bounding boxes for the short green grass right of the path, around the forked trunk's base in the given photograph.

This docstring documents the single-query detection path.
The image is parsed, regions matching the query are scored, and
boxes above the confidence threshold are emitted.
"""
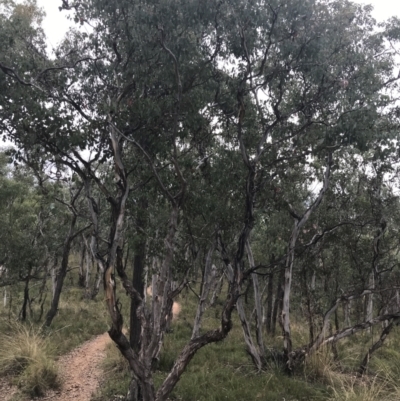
[94,293,332,401]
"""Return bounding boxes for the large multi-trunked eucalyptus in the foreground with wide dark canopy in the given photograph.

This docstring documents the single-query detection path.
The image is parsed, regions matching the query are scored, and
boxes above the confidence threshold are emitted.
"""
[0,0,398,400]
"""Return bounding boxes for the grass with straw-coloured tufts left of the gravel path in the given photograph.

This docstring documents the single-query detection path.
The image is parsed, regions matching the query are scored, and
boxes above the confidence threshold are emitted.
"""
[0,266,108,401]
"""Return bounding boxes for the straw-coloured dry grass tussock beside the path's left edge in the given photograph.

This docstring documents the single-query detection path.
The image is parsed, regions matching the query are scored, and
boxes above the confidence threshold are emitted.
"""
[0,322,59,396]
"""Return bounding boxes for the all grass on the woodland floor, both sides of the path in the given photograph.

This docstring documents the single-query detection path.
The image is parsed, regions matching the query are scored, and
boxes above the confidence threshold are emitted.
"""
[0,266,400,401]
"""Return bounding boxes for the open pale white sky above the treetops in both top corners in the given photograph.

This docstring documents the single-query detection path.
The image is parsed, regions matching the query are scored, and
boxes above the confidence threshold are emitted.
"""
[37,0,400,49]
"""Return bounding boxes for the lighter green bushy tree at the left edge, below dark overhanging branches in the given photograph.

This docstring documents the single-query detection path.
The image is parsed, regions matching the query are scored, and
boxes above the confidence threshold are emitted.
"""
[0,153,51,320]
